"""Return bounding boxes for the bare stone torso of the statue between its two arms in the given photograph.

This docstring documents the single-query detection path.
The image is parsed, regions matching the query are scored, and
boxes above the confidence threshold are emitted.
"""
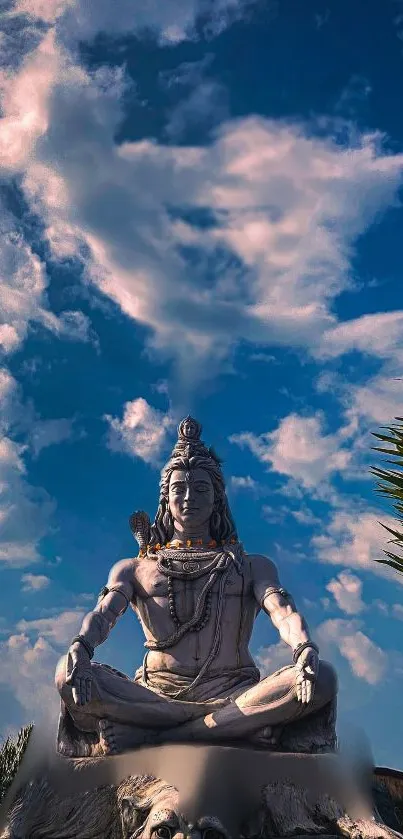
[132,552,259,676]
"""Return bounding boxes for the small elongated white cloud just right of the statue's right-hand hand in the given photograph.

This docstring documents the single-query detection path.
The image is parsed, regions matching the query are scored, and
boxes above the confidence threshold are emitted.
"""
[316,618,388,685]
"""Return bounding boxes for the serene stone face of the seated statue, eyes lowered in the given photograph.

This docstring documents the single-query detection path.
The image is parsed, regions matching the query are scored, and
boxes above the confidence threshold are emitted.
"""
[168,469,214,529]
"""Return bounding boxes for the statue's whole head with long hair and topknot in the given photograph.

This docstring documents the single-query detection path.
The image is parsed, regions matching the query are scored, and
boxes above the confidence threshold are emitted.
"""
[150,417,237,545]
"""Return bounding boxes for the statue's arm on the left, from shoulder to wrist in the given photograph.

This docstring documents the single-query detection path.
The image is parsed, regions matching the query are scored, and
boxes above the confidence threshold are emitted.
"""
[73,559,135,657]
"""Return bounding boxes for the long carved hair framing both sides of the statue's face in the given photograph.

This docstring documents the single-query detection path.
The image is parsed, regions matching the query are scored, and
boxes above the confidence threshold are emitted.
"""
[150,449,238,547]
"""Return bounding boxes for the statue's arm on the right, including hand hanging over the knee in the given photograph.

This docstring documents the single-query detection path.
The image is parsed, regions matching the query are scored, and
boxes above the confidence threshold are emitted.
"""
[249,555,319,703]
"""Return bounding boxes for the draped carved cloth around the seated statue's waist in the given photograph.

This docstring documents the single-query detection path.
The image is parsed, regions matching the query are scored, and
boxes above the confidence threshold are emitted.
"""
[134,665,260,704]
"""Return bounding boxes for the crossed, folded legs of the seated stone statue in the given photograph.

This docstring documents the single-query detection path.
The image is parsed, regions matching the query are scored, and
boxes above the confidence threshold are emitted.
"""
[56,659,336,753]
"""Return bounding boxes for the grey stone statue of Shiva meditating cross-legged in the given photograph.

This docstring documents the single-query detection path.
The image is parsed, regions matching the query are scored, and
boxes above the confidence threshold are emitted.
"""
[55,417,337,757]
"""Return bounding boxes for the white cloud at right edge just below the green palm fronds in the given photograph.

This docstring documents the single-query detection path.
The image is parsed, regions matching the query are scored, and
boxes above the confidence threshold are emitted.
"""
[311,509,403,584]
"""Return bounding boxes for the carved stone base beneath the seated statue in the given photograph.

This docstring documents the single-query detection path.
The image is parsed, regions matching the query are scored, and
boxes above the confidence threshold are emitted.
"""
[0,732,403,839]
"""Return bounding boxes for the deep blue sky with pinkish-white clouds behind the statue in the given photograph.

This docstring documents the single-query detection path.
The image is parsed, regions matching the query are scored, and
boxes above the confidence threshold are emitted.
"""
[0,0,403,767]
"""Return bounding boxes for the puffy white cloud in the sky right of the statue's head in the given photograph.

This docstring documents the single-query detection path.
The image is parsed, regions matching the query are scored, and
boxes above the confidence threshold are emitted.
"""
[230,414,351,489]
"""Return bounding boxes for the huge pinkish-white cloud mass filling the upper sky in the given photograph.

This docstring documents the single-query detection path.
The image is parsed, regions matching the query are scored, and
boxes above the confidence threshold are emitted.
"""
[0,0,403,386]
